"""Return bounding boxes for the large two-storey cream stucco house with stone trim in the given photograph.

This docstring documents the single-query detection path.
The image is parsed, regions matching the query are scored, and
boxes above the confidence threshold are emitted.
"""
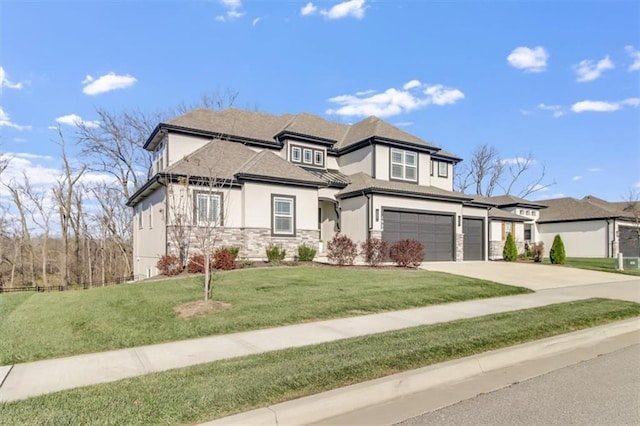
[127,108,492,275]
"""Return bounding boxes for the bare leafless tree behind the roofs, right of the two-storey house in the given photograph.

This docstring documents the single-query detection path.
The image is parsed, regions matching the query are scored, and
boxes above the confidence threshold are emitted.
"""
[454,144,553,197]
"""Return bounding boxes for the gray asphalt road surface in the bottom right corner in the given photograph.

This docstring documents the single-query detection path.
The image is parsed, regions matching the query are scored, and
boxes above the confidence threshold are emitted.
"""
[397,344,640,426]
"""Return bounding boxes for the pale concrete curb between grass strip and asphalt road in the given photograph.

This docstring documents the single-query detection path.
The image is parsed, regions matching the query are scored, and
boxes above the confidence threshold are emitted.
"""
[203,318,640,426]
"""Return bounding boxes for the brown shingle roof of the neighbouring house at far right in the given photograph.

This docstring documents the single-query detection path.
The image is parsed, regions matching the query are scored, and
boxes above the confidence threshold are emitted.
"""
[538,196,634,223]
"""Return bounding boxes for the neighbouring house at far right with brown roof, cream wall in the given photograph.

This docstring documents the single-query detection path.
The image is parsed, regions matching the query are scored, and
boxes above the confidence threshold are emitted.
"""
[537,195,640,257]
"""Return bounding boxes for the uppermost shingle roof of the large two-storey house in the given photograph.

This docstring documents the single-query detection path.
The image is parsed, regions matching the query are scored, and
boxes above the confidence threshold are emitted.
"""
[150,108,461,162]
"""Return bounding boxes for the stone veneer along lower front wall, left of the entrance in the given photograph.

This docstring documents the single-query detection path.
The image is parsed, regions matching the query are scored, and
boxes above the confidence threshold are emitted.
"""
[169,228,320,259]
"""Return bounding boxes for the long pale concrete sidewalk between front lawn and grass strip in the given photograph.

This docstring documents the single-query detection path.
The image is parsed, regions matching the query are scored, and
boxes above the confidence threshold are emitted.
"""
[0,291,591,402]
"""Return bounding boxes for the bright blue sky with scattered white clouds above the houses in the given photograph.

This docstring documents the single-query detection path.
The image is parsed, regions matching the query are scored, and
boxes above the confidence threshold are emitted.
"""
[0,0,640,201]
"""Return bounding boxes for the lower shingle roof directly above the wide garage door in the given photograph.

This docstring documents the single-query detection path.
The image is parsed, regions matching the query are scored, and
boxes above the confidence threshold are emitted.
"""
[336,172,471,201]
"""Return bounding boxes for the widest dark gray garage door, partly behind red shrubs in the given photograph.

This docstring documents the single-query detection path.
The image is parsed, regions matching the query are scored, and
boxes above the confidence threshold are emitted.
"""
[382,210,454,261]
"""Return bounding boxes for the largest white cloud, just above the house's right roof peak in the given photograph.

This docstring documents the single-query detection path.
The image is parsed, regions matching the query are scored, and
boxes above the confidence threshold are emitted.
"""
[326,80,464,118]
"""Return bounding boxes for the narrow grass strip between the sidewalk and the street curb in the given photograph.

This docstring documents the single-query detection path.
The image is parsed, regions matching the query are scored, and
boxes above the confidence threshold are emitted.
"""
[0,299,640,425]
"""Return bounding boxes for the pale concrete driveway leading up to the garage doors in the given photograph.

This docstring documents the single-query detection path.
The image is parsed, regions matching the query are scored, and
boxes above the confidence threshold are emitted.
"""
[421,262,640,293]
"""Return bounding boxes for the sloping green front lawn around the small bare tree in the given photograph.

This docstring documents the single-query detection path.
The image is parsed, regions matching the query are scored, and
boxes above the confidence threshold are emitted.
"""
[0,267,529,365]
